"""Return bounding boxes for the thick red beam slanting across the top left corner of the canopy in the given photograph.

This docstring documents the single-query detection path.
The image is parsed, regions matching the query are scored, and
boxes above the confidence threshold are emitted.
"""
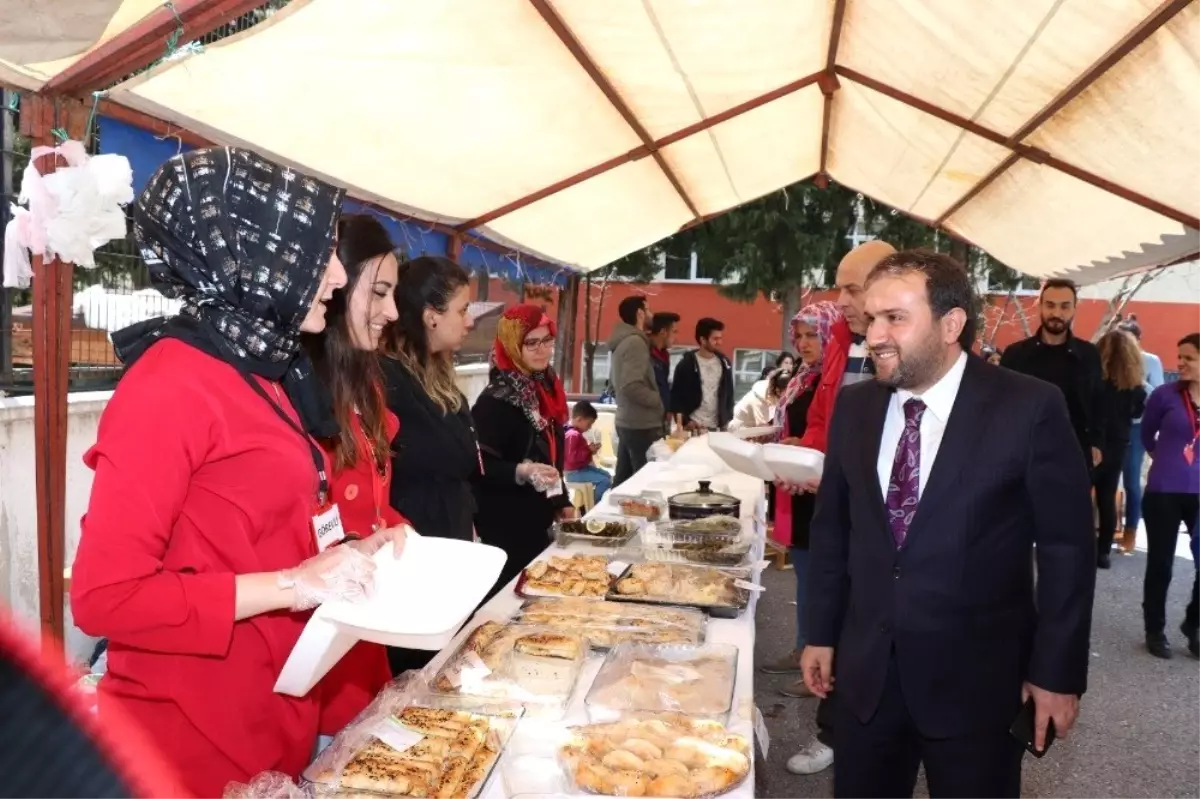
[42,0,270,95]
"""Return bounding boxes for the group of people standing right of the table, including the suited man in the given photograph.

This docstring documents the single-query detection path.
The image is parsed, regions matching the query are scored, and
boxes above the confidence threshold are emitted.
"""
[760,241,1200,797]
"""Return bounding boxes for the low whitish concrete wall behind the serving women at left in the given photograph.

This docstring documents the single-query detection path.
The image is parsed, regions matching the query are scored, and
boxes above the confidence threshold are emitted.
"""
[0,364,487,661]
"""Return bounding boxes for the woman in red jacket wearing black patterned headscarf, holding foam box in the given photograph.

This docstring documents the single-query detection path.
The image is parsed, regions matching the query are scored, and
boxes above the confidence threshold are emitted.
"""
[71,148,408,799]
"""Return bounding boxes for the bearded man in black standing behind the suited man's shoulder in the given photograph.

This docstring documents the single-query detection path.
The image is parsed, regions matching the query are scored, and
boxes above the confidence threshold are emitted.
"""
[1000,278,1104,469]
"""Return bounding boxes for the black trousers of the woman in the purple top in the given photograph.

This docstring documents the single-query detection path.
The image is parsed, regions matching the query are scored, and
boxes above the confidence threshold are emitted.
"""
[1141,491,1200,635]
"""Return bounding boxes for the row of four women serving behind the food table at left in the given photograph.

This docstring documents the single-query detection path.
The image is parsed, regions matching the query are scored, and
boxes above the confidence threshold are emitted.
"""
[71,148,585,797]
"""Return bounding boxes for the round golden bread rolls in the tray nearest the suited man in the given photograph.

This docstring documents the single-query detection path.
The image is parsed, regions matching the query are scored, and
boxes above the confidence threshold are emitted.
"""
[559,714,750,799]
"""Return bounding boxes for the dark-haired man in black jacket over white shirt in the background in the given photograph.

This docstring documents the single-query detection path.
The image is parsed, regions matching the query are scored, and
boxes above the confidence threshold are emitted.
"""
[671,317,733,431]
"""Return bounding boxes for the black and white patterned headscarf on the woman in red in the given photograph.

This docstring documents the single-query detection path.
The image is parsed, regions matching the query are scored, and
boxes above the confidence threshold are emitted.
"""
[113,148,344,438]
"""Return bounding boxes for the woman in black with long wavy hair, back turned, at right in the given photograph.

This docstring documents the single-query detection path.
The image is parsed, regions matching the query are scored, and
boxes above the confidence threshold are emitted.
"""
[1092,330,1146,569]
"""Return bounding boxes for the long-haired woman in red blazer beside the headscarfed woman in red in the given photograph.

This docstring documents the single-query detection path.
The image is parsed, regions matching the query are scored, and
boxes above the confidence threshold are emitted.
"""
[306,214,408,735]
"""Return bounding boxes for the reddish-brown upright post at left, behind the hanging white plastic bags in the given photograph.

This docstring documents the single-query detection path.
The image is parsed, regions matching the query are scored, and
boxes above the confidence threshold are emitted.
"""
[22,95,82,645]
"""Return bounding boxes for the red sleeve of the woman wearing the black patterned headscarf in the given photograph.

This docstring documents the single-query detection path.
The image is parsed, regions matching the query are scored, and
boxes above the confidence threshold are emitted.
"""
[71,352,235,656]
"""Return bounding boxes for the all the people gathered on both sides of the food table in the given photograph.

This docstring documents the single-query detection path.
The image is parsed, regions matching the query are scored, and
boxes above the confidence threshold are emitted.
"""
[60,148,1200,797]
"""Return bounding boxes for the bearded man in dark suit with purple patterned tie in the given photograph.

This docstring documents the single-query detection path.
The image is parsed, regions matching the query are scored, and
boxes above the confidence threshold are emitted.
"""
[802,252,1096,799]
